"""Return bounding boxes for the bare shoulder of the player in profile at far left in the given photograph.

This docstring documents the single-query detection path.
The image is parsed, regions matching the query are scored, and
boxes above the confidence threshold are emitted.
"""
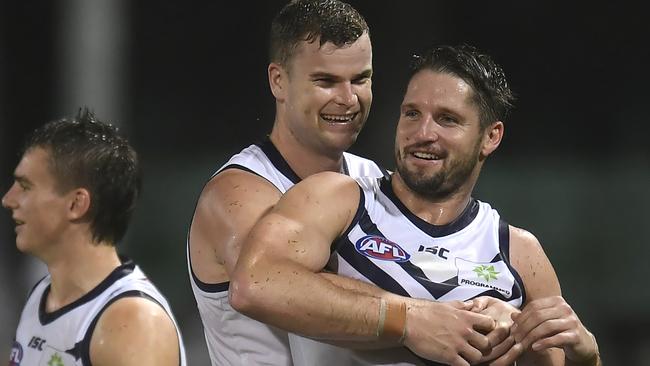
[90,297,180,366]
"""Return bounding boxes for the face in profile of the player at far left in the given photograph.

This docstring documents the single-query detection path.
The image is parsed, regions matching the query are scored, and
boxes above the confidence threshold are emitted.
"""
[2,147,68,254]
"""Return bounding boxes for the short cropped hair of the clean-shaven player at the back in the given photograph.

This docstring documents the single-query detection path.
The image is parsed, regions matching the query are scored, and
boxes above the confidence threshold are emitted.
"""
[269,0,370,65]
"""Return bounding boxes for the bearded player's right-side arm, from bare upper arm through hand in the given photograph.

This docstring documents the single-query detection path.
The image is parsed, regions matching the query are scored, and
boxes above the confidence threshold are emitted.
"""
[494,227,601,366]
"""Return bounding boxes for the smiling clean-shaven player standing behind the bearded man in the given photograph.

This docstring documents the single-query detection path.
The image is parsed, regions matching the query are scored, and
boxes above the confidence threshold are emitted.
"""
[182,0,383,366]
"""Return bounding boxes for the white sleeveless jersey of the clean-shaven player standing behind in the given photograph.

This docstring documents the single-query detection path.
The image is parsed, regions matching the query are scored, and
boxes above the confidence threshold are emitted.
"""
[187,139,385,366]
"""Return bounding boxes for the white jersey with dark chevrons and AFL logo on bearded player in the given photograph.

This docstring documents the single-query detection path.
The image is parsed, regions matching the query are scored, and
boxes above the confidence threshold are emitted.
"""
[330,179,525,365]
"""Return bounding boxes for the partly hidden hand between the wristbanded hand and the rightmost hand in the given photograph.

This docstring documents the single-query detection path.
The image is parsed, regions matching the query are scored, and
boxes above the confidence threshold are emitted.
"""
[467,296,520,363]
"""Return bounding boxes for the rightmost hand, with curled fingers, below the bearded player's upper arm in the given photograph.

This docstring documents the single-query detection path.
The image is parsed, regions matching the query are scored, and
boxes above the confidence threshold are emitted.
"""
[491,296,599,366]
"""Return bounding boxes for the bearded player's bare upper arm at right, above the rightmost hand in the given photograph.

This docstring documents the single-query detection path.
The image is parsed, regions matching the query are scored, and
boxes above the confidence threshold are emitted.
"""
[510,225,561,302]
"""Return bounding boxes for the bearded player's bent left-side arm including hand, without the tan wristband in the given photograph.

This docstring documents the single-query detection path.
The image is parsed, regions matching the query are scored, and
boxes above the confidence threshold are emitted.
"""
[230,173,494,365]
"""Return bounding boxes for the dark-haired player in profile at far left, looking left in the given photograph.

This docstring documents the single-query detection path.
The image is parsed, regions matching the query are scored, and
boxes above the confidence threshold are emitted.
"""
[2,109,186,366]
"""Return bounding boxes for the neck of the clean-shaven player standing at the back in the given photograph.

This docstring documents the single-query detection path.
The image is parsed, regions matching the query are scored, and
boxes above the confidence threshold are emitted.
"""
[270,125,343,179]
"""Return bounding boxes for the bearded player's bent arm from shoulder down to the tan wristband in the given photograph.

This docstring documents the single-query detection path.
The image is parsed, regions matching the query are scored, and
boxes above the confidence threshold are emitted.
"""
[229,173,379,339]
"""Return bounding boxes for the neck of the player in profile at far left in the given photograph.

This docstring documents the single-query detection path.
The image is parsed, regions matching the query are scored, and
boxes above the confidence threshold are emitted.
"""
[46,240,120,312]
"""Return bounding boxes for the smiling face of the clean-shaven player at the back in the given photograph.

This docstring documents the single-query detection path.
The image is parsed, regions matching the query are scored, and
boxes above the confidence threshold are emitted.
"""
[284,34,372,154]
